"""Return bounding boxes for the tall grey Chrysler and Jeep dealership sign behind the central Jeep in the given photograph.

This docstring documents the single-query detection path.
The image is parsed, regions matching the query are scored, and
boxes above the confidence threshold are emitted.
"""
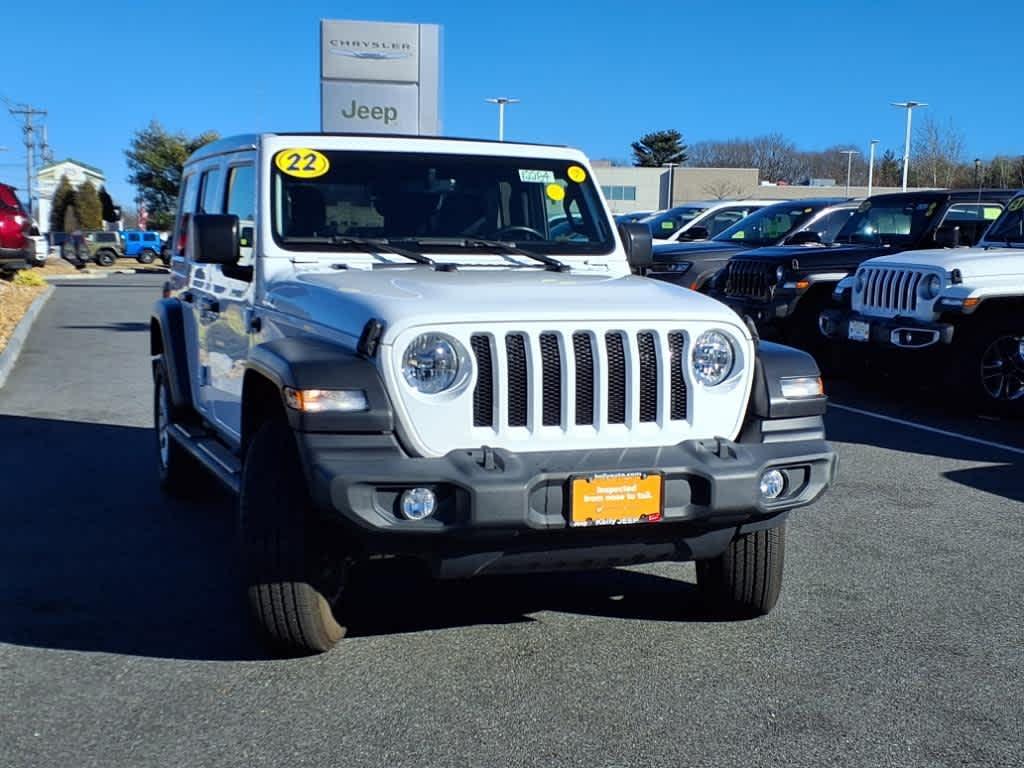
[321,19,440,136]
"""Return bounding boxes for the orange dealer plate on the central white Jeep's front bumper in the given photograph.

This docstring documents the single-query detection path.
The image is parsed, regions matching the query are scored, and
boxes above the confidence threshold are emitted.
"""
[569,472,663,527]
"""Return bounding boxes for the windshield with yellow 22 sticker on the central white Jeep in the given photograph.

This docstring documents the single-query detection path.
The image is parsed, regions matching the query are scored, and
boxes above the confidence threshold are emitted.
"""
[272,150,614,255]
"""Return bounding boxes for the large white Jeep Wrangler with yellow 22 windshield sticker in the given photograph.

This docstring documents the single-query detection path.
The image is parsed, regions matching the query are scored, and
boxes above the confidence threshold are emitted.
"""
[152,134,836,652]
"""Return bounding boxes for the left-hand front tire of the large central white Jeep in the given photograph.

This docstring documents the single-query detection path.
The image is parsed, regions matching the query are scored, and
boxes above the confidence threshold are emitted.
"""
[239,421,348,655]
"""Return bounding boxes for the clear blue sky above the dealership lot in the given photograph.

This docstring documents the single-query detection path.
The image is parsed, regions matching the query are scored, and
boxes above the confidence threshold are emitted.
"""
[0,0,1024,208]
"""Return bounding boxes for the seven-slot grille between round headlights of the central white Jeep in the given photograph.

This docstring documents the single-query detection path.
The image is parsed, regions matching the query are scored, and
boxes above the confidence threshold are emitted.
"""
[470,331,687,430]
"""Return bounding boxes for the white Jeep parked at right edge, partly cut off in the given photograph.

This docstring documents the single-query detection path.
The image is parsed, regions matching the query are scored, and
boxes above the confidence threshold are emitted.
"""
[818,195,1024,416]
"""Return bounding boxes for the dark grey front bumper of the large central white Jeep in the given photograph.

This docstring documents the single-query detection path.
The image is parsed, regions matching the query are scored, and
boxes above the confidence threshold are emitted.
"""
[298,428,837,574]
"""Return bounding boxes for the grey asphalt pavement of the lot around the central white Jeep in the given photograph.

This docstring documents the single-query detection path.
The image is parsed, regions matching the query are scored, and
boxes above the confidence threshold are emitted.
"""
[0,275,1024,768]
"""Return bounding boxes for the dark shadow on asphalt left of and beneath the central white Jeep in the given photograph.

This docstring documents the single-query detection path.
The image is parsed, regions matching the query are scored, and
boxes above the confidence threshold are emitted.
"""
[0,415,713,660]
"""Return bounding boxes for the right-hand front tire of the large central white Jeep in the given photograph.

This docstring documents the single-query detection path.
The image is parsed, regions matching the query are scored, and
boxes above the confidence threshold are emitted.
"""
[696,523,785,618]
